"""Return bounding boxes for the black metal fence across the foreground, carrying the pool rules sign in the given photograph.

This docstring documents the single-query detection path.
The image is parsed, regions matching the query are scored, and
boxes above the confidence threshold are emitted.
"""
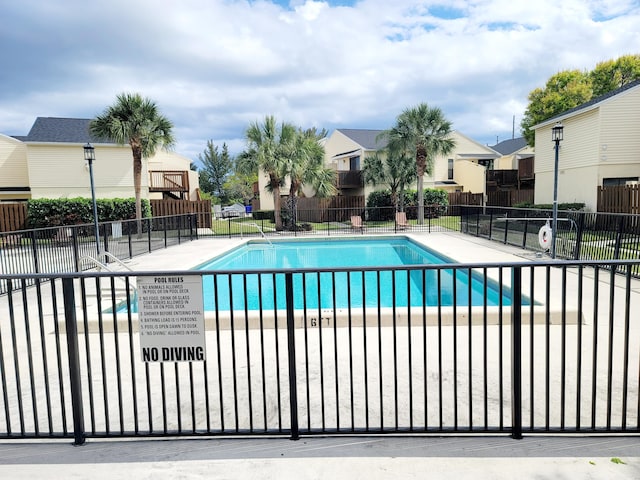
[0,261,640,444]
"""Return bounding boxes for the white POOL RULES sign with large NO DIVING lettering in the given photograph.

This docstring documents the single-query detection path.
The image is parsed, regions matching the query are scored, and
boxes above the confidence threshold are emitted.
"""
[137,275,205,362]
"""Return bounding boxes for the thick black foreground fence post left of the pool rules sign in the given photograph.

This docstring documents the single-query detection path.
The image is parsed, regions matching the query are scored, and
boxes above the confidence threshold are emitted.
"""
[62,278,85,445]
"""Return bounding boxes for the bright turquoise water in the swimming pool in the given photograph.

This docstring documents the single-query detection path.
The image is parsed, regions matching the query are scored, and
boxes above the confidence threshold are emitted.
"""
[198,238,511,310]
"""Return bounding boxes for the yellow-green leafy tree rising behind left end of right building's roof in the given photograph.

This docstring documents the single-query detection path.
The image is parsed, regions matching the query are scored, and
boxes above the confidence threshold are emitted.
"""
[520,70,592,146]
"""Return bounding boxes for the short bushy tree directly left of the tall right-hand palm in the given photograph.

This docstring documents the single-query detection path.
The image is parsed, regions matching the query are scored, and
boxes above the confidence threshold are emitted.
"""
[362,147,416,211]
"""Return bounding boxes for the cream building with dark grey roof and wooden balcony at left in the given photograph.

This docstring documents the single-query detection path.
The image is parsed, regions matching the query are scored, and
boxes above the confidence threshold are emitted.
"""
[0,117,199,201]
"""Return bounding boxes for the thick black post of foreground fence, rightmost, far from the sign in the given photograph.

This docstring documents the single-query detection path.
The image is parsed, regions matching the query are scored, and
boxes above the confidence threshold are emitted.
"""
[511,267,533,440]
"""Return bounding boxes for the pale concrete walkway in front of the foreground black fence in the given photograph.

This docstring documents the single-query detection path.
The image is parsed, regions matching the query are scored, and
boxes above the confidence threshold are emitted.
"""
[0,436,640,480]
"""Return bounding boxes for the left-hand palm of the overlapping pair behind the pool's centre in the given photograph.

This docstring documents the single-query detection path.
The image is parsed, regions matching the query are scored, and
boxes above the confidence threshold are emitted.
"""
[240,115,297,230]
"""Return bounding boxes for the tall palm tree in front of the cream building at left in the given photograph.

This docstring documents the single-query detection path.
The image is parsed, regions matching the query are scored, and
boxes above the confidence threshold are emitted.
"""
[89,93,175,221]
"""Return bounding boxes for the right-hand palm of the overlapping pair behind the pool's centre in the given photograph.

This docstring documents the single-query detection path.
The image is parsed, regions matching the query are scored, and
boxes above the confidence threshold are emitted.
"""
[286,128,336,228]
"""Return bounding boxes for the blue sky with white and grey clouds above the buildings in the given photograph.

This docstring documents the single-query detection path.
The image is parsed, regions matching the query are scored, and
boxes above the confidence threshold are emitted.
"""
[0,0,640,160]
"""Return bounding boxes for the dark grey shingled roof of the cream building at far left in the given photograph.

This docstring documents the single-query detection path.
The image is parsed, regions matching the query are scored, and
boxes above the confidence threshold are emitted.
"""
[14,117,114,144]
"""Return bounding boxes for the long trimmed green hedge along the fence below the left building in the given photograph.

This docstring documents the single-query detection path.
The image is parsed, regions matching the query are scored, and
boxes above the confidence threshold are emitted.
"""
[27,197,151,228]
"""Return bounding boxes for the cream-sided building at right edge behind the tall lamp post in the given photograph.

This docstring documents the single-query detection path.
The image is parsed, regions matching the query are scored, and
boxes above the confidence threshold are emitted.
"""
[533,81,640,211]
